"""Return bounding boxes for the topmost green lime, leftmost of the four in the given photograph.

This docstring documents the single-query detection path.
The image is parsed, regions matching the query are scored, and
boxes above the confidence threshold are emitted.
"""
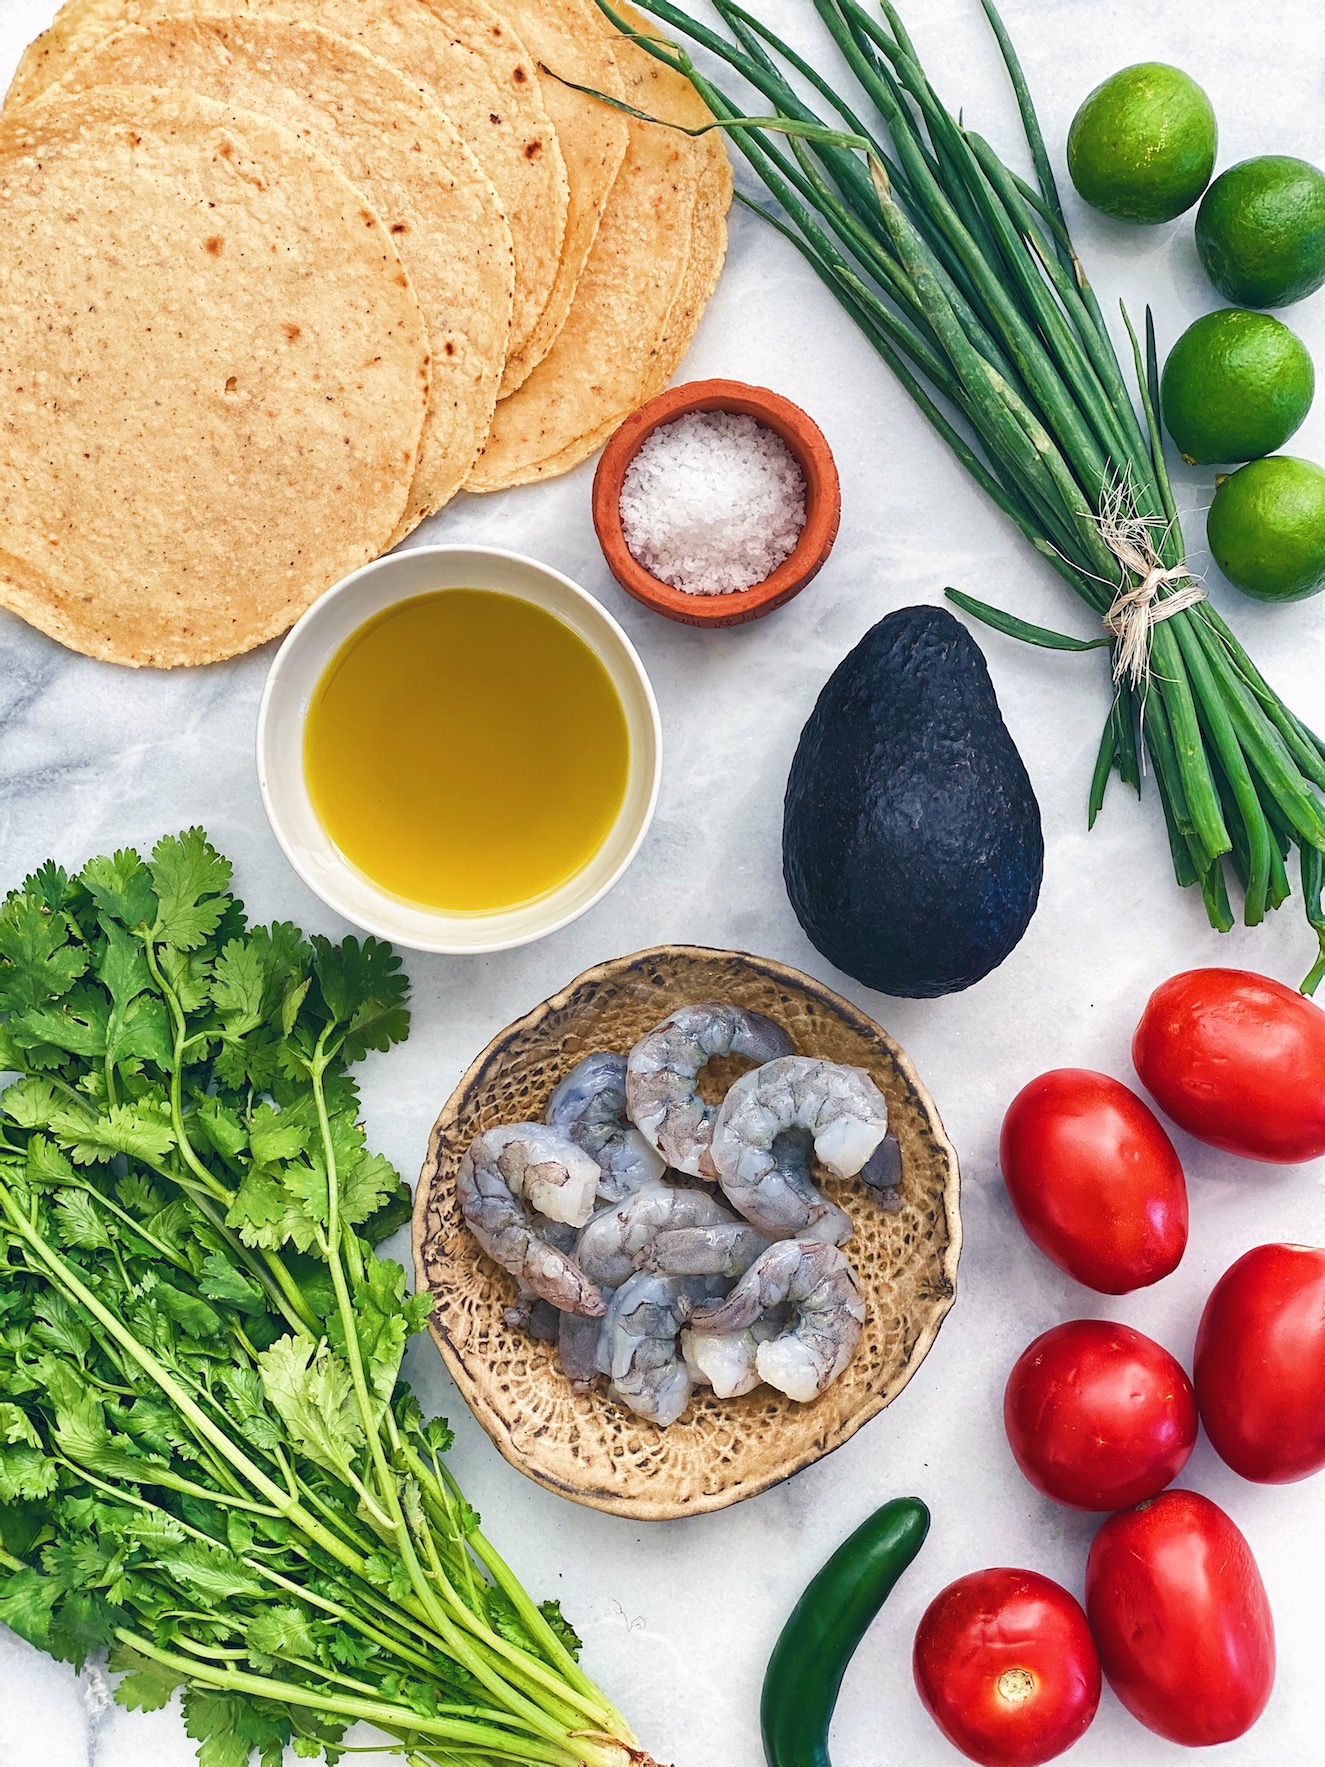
[1067,62,1219,221]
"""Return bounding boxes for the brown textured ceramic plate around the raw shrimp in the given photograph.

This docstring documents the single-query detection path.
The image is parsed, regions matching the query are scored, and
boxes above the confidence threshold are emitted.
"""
[413,945,961,1521]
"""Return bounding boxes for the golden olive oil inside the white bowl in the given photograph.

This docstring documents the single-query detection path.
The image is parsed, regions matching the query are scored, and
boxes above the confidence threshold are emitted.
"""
[304,588,631,914]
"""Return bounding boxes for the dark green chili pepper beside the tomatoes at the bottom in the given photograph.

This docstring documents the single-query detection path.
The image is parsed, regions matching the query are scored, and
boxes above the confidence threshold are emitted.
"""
[760,1497,929,1767]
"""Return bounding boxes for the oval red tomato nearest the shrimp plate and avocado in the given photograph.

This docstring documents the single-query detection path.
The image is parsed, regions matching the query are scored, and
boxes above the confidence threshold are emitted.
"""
[998,1067,1187,1295]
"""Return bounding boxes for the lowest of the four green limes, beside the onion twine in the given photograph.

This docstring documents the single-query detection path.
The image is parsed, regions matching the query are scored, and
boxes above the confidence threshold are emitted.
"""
[1205,454,1325,601]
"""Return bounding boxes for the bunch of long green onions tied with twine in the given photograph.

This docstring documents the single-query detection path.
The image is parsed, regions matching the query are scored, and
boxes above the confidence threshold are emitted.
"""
[586,0,1325,993]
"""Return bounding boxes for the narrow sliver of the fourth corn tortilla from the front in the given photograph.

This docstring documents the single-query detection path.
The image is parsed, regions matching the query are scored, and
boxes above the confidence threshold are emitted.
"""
[502,0,629,398]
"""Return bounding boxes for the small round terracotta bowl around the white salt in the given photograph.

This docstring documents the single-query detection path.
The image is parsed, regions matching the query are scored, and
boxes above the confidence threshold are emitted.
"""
[594,380,843,626]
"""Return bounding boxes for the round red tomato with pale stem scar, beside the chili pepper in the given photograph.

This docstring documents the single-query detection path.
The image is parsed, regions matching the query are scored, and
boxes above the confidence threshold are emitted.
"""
[912,1571,1099,1767]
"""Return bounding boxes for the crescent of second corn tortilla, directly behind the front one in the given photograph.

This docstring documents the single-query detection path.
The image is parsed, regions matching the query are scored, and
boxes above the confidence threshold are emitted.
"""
[53,14,514,541]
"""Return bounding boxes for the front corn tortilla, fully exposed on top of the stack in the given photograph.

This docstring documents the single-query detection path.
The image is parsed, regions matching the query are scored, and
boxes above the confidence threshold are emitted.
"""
[0,87,428,668]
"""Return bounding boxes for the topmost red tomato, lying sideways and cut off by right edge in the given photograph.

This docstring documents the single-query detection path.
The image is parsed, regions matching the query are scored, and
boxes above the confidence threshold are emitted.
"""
[1132,970,1325,1166]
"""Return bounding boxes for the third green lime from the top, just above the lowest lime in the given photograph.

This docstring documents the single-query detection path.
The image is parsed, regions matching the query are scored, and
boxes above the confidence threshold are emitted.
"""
[1159,307,1316,465]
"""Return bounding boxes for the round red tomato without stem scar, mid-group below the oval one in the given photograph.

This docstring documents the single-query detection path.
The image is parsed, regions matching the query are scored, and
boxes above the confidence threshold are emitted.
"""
[1003,1320,1196,1509]
